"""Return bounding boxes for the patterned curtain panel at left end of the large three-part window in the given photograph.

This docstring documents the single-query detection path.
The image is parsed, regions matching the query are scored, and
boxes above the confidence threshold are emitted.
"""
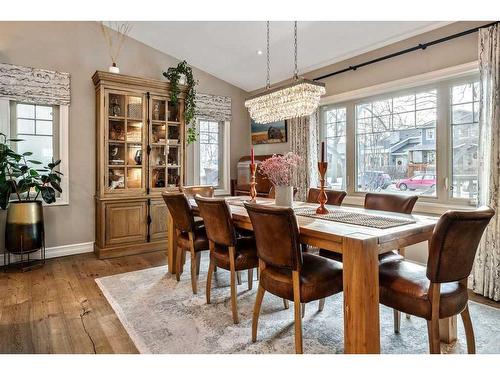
[288,111,319,201]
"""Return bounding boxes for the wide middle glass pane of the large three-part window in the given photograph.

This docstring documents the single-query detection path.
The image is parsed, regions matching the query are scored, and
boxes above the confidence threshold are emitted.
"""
[356,89,437,196]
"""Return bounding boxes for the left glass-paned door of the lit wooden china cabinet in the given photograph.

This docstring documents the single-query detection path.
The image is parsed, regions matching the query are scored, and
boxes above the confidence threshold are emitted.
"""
[105,91,145,192]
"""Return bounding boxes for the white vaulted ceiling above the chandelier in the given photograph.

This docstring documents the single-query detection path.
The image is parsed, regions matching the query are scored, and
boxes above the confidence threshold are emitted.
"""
[122,21,446,91]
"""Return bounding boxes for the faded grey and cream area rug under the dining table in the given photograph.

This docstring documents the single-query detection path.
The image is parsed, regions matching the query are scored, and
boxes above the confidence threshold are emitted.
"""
[96,254,500,354]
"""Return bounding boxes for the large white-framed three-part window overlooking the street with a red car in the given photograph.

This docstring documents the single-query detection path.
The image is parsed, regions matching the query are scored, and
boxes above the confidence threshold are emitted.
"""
[321,73,479,209]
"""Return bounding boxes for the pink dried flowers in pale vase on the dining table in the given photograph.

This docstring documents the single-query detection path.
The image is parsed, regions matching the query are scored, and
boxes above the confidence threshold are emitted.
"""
[259,152,302,207]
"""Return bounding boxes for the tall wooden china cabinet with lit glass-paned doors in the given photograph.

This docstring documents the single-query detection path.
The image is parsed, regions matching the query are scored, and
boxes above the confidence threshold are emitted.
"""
[92,71,186,258]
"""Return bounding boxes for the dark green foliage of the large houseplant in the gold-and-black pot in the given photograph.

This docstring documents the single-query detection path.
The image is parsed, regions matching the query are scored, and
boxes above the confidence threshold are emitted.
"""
[0,133,62,210]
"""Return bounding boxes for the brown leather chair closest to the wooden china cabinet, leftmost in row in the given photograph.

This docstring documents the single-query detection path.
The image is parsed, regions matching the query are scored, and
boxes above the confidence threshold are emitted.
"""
[162,192,209,294]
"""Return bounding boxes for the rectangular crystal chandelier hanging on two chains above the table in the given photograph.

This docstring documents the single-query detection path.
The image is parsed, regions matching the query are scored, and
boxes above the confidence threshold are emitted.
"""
[245,21,325,124]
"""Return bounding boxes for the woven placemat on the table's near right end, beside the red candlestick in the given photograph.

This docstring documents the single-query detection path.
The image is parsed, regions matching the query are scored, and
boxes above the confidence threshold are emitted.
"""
[294,207,415,229]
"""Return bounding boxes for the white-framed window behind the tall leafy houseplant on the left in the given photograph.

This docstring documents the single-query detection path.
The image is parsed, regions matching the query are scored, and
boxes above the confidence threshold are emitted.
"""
[0,98,69,205]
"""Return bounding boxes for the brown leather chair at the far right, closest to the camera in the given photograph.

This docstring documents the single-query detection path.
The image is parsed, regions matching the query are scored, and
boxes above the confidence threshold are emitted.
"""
[380,207,495,354]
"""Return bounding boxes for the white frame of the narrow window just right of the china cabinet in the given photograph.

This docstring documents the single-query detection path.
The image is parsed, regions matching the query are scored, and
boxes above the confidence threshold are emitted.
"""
[193,118,231,195]
